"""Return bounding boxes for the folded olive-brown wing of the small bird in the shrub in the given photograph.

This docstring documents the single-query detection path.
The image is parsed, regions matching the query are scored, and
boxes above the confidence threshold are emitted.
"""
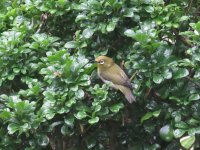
[100,64,132,89]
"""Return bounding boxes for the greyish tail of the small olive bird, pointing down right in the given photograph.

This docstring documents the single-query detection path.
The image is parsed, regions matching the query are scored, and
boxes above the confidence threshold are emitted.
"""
[116,85,136,103]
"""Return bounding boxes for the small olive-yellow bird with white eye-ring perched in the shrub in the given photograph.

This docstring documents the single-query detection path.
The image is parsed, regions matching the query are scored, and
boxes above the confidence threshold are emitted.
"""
[95,56,135,103]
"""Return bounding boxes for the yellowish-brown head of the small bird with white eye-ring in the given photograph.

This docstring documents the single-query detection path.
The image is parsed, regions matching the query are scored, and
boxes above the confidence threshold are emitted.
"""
[95,56,114,69]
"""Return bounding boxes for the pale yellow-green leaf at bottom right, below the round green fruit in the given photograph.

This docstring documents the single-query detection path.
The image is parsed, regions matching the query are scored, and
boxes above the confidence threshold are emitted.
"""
[180,136,195,149]
